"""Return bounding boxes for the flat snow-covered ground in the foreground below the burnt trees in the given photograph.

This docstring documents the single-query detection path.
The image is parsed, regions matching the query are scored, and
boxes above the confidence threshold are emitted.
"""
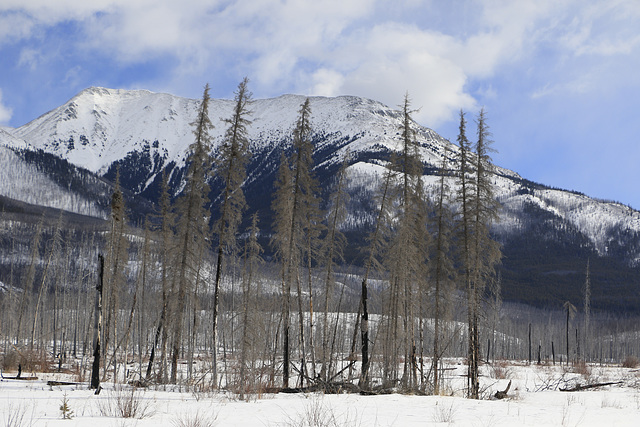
[0,363,640,427]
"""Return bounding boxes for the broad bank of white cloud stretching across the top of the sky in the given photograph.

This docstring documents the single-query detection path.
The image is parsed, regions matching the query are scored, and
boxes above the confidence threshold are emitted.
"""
[0,0,640,126]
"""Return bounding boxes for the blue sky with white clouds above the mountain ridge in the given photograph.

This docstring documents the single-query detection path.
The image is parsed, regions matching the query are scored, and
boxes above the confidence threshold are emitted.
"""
[0,0,640,208]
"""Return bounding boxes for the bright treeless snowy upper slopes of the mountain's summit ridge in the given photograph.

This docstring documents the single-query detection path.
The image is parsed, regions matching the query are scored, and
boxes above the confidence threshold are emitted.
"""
[13,88,456,180]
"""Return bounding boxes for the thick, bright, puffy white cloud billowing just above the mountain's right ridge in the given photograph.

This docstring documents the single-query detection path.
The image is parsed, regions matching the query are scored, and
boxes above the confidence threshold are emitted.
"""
[308,24,475,126]
